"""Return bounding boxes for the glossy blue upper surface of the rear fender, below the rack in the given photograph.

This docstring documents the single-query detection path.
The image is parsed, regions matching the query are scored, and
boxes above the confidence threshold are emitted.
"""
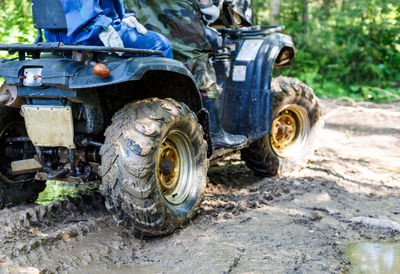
[0,57,194,89]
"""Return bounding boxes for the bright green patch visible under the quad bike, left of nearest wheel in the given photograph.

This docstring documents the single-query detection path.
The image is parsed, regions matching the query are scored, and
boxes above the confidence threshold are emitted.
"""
[36,181,99,205]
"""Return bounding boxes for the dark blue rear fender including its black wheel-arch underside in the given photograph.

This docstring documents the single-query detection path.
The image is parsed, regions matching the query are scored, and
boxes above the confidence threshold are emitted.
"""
[0,55,211,150]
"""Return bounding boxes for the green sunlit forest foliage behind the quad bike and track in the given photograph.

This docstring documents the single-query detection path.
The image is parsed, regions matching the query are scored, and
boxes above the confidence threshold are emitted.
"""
[0,0,400,102]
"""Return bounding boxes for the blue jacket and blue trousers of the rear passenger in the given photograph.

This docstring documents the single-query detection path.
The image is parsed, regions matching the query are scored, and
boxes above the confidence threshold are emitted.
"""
[44,0,173,58]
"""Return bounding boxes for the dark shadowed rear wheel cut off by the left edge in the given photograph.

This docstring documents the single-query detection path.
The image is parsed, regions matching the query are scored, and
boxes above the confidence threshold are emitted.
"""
[0,105,46,208]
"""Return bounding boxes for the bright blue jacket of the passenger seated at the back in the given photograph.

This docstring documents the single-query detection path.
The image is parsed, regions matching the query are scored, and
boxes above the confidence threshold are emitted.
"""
[45,0,135,45]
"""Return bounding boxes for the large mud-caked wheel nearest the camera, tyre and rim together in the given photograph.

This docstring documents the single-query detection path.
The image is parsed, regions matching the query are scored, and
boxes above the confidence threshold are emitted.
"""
[101,98,207,237]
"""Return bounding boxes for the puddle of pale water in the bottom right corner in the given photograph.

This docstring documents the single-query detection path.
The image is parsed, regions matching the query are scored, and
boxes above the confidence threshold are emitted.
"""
[343,242,400,274]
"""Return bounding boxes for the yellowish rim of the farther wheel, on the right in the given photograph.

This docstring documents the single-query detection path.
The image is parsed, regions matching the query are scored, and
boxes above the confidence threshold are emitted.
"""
[270,105,310,158]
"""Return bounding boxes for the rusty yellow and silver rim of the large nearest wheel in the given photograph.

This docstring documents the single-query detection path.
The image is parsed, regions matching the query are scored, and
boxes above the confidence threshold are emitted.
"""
[156,130,194,205]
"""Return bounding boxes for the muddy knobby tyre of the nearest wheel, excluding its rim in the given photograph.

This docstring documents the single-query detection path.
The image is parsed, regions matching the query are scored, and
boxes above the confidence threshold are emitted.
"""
[100,98,207,237]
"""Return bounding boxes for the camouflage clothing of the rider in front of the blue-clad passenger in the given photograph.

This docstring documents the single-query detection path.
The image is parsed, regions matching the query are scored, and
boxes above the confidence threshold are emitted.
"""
[125,0,220,98]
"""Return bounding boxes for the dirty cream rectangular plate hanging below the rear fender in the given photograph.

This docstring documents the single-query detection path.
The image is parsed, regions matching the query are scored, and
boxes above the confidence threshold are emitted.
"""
[21,105,75,148]
